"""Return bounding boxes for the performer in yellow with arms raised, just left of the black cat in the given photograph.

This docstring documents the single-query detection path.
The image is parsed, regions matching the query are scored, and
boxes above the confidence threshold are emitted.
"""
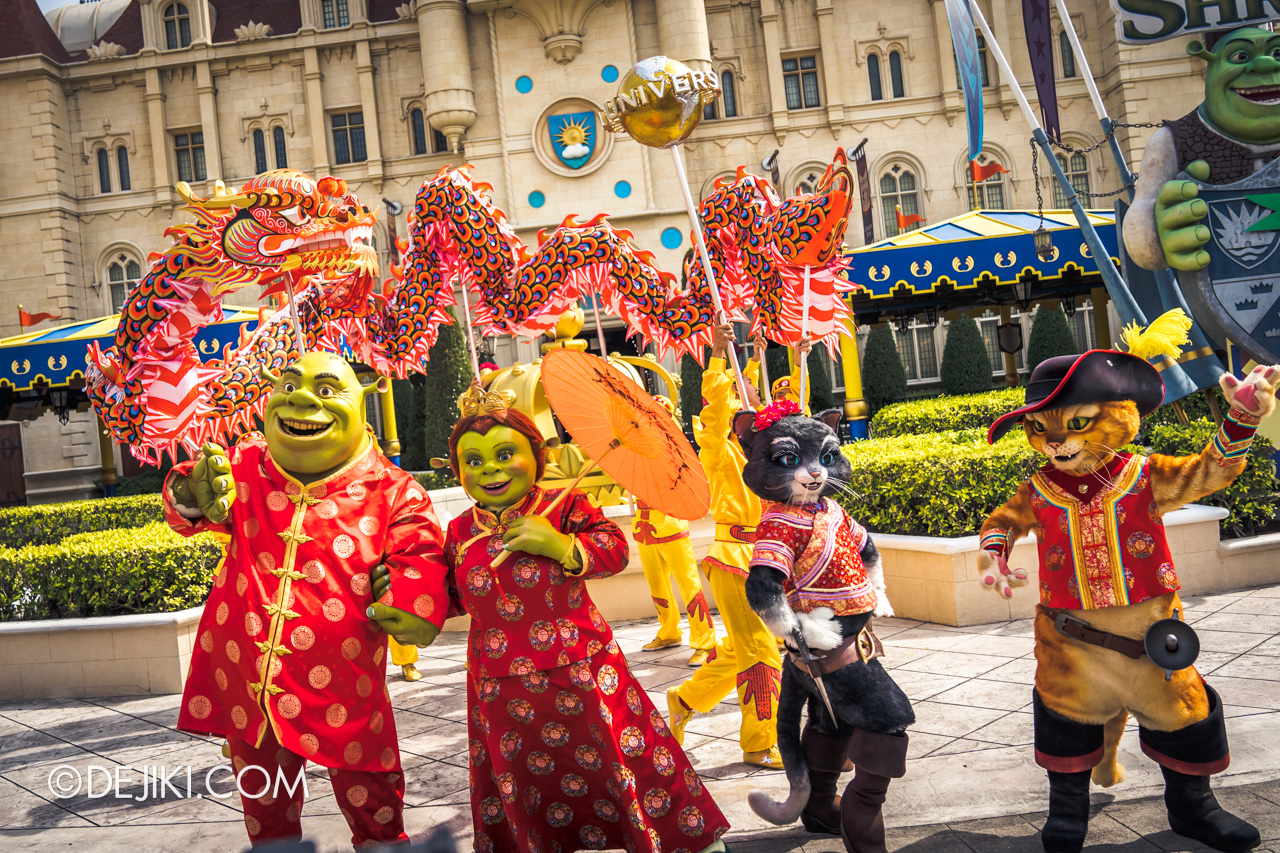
[667,357,782,768]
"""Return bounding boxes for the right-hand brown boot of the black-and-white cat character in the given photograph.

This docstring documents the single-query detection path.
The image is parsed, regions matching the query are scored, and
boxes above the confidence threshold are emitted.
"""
[840,729,908,853]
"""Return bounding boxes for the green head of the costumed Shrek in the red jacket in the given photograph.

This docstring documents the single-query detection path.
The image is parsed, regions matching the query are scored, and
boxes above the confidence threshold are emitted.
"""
[262,352,387,483]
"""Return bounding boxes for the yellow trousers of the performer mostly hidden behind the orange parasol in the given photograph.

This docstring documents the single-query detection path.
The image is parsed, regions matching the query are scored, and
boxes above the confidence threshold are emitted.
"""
[631,505,716,666]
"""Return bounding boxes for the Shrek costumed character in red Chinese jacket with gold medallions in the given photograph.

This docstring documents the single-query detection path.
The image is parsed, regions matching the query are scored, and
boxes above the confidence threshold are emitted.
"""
[164,352,448,845]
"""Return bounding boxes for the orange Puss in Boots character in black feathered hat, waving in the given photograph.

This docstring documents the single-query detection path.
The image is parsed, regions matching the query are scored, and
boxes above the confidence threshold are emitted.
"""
[978,315,1280,853]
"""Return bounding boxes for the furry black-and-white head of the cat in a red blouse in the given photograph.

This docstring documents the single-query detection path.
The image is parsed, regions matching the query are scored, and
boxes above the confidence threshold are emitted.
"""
[735,410,852,503]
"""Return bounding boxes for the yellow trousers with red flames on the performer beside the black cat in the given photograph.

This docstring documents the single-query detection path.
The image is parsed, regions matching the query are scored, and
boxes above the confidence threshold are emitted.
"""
[676,543,782,752]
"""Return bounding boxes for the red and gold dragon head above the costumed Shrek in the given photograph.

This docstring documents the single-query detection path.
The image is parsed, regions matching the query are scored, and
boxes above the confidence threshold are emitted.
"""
[170,169,378,314]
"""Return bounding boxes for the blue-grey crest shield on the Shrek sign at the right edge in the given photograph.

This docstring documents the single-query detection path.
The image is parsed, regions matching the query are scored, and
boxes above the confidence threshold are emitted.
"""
[1178,161,1280,364]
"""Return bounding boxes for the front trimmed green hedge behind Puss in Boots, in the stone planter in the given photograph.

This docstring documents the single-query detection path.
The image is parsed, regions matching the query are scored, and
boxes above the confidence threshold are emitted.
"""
[837,421,1280,538]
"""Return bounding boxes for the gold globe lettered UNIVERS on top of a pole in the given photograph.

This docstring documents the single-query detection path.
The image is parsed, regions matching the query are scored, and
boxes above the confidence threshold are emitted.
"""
[604,56,719,149]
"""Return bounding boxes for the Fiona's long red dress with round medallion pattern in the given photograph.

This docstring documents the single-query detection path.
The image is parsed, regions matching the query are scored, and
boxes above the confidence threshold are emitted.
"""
[445,487,728,853]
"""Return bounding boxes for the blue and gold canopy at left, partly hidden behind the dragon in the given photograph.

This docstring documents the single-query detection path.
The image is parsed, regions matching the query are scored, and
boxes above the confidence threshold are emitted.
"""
[0,307,259,392]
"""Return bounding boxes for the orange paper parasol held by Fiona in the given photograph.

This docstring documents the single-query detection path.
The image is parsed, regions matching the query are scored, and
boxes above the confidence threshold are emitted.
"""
[543,350,710,520]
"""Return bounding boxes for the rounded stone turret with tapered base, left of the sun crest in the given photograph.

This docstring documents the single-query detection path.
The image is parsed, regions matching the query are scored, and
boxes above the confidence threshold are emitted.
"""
[416,0,478,151]
